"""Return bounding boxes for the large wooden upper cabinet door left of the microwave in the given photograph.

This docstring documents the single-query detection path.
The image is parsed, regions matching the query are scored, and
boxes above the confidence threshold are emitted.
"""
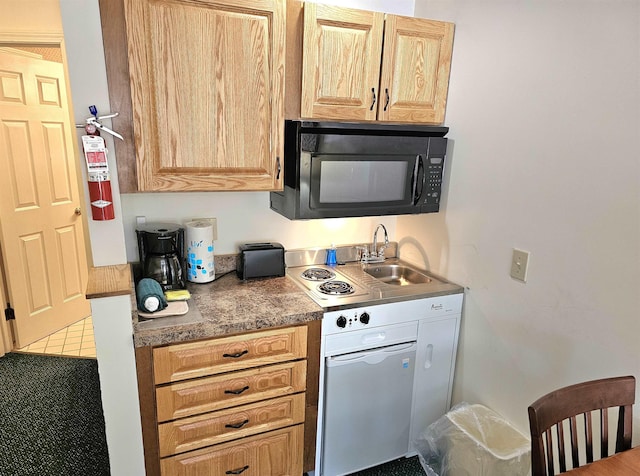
[125,0,285,191]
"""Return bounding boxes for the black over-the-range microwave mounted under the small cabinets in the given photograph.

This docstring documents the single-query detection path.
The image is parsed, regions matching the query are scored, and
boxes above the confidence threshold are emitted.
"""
[270,121,449,220]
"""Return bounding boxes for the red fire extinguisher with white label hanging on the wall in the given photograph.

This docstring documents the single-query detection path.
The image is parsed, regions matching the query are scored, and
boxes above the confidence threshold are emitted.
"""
[82,131,115,220]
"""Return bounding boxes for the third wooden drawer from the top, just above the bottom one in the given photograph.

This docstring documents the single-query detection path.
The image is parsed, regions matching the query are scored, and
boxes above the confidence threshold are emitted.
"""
[158,393,305,457]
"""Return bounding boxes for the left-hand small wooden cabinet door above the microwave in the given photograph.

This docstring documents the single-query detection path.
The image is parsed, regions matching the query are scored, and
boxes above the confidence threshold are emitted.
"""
[301,3,384,121]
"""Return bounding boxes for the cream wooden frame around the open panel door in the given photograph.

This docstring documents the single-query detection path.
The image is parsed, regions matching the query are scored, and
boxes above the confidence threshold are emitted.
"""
[0,28,93,357]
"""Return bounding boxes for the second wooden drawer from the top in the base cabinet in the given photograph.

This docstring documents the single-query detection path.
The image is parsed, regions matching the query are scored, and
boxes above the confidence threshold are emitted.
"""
[156,360,307,422]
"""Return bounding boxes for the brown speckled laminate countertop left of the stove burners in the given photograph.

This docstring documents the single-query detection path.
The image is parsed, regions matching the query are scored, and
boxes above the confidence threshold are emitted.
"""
[132,256,323,347]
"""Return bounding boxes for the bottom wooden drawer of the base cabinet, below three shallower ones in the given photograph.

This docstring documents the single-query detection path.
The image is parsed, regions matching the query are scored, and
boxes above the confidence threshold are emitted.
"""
[160,425,303,476]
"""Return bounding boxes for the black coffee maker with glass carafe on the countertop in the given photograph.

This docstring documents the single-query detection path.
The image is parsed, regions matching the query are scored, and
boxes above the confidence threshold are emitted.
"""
[136,223,185,291]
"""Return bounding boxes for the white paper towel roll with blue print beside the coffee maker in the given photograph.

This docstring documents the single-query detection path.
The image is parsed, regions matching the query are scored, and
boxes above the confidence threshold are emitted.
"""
[185,219,216,283]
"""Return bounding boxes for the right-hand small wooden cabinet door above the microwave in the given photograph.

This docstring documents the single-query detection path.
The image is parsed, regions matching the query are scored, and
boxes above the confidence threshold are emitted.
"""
[378,15,454,124]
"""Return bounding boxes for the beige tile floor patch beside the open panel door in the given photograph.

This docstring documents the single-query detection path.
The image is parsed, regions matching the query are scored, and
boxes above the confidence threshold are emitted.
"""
[18,316,96,358]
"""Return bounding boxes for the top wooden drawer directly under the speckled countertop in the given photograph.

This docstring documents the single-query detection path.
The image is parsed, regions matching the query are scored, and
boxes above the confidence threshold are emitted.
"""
[153,326,307,384]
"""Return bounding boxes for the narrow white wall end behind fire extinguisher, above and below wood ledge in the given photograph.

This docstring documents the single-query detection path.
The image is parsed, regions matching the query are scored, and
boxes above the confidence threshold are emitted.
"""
[60,0,144,476]
